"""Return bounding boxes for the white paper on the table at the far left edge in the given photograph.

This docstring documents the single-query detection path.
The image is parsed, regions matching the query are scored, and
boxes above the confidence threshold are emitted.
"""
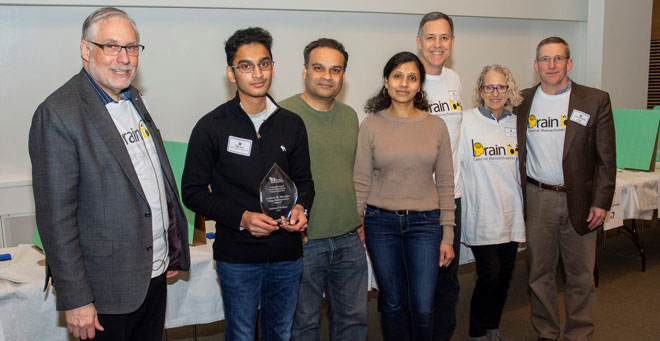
[0,244,46,283]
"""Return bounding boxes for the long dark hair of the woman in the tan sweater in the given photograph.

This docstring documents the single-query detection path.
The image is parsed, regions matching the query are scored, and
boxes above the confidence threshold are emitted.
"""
[364,51,429,114]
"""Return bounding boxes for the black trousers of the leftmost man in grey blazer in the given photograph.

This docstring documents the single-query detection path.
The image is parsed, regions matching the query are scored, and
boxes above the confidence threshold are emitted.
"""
[94,274,167,341]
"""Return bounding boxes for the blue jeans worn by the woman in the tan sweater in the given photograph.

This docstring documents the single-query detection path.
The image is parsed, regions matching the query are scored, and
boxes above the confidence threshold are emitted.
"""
[364,206,442,341]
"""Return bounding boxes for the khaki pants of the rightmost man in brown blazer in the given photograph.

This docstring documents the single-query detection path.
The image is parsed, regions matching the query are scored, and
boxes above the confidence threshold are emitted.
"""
[526,184,597,340]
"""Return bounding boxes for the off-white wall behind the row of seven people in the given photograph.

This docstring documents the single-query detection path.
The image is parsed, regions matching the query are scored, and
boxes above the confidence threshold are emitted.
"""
[0,0,651,189]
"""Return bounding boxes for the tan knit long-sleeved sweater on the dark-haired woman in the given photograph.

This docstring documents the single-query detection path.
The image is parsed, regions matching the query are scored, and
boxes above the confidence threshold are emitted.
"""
[353,111,456,243]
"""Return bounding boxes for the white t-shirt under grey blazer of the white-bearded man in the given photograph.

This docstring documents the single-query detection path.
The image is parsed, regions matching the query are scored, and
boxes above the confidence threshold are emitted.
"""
[105,100,169,278]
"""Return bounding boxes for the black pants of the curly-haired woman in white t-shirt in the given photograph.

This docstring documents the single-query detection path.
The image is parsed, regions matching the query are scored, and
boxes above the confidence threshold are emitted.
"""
[470,242,518,337]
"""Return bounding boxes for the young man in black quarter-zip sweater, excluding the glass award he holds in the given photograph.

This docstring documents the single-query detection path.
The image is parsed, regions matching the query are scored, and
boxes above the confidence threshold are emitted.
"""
[182,27,314,340]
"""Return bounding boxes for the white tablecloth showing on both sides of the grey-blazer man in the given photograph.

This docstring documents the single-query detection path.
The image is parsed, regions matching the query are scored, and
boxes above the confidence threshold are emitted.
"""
[0,241,225,340]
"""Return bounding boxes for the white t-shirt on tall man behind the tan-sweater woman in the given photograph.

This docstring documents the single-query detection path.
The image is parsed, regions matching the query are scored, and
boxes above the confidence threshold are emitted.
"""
[424,67,463,198]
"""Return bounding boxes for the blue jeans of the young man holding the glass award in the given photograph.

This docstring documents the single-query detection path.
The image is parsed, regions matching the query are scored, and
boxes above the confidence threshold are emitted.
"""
[216,258,302,341]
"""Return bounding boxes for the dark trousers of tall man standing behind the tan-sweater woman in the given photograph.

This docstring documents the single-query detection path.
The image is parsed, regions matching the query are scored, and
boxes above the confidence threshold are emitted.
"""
[433,198,461,341]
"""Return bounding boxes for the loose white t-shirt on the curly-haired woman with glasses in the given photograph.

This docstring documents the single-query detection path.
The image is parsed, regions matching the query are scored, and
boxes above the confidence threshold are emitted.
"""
[459,108,525,245]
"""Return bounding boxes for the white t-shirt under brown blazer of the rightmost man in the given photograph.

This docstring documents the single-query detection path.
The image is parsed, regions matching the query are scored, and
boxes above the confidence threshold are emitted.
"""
[527,86,571,185]
